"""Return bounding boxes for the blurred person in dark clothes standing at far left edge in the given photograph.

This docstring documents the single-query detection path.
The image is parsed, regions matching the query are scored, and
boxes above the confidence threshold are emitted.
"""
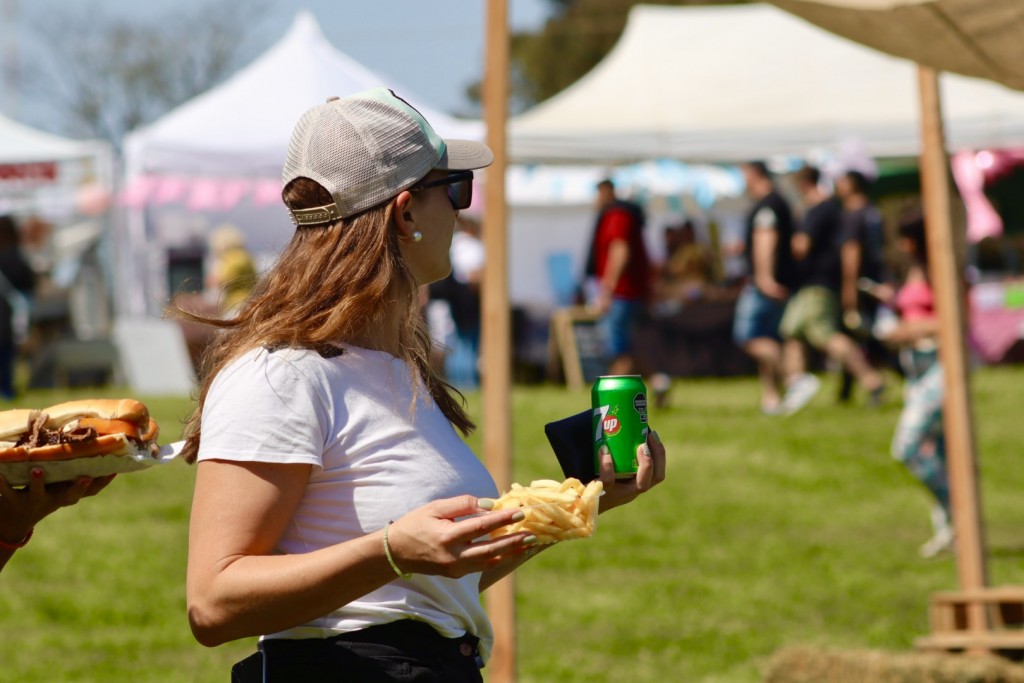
[0,215,36,400]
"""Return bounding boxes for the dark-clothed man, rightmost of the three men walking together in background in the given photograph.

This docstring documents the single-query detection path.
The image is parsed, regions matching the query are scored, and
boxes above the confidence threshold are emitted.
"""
[836,171,886,408]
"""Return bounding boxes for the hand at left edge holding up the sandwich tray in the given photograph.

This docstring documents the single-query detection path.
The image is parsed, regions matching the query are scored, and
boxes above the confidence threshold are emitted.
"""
[0,467,117,569]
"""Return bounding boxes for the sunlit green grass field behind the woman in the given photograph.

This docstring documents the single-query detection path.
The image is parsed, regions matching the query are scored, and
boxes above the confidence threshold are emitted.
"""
[0,368,1024,683]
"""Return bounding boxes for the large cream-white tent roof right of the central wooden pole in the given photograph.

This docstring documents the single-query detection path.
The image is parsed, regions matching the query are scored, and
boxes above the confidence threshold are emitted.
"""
[508,4,1024,162]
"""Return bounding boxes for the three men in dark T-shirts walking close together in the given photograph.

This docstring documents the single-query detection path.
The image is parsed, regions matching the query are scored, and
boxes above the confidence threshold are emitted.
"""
[733,162,885,415]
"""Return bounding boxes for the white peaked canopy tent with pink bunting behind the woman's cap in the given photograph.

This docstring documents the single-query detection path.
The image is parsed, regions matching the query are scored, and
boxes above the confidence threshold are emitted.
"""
[117,11,483,315]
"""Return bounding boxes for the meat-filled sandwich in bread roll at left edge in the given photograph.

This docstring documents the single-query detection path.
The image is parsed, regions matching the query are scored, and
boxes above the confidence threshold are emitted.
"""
[0,398,160,462]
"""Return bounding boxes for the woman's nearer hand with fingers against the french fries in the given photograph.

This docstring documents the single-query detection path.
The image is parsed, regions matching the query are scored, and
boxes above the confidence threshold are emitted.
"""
[388,496,534,579]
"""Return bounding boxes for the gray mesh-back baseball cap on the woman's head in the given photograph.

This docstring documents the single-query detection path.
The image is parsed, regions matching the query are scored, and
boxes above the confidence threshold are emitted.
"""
[283,88,495,225]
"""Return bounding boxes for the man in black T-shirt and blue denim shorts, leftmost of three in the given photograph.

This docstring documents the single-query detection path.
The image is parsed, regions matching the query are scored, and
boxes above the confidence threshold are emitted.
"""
[732,161,797,415]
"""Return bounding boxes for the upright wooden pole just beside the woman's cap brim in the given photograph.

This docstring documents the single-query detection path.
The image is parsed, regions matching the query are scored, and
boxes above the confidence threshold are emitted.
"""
[481,0,516,683]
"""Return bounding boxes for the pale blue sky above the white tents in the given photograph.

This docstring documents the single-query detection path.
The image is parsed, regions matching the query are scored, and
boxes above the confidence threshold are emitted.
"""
[6,0,549,132]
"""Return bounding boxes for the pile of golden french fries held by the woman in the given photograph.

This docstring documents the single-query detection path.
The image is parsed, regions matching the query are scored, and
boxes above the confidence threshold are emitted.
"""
[490,477,604,544]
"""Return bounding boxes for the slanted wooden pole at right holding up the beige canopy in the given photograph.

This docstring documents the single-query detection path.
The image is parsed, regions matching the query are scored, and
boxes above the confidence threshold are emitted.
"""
[918,66,988,631]
